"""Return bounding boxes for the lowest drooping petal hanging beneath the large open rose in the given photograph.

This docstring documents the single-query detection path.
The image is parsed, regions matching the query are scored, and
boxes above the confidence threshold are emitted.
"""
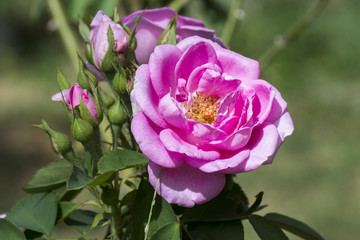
[148,161,225,207]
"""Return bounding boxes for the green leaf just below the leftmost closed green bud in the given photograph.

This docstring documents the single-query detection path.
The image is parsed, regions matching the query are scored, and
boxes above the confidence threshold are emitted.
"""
[23,159,73,193]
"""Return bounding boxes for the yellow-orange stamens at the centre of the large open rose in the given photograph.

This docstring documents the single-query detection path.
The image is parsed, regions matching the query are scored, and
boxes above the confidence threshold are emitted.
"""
[184,92,220,124]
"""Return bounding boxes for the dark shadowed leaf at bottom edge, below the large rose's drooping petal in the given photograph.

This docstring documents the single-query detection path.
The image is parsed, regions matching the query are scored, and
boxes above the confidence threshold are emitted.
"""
[190,220,244,240]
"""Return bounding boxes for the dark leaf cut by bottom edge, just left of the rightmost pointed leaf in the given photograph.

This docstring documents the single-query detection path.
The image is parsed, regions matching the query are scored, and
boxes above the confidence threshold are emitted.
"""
[248,215,288,240]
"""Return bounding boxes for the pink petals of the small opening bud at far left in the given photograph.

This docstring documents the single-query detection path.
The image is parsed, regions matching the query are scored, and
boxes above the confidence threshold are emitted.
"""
[51,83,97,119]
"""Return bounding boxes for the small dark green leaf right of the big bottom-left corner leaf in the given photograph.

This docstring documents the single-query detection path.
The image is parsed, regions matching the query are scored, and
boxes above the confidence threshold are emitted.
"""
[64,209,100,235]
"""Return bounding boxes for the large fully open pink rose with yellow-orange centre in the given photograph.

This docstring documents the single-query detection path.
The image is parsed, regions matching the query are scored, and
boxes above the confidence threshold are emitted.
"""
[131,37,293,207]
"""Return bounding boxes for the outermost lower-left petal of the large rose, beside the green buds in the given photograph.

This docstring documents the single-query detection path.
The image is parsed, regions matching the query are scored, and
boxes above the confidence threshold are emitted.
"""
[131,113,184,168]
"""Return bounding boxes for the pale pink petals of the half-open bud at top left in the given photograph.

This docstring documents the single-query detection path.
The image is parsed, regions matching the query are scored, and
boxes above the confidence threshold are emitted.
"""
[89,11,128,69]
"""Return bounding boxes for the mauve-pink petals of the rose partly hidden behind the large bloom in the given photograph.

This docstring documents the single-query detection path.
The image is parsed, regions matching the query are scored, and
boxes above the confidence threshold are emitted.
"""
[121,8,225,64]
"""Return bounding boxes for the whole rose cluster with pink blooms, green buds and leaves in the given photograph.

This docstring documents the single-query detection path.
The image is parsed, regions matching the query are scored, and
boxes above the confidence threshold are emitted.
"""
[0,8,322,240]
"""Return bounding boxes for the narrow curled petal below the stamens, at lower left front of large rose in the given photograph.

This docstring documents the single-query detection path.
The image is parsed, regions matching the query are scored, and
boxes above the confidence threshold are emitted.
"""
[160,129,220,161]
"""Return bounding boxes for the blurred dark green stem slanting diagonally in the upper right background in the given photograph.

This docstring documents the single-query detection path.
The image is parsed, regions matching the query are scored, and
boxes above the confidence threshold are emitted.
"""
[260,0,330,71]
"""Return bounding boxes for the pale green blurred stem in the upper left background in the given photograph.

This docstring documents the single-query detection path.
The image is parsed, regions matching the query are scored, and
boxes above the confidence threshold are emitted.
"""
[48,0,79,71]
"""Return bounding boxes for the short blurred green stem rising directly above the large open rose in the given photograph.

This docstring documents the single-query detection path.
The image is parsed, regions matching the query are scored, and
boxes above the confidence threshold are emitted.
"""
[222,0,242,46]
